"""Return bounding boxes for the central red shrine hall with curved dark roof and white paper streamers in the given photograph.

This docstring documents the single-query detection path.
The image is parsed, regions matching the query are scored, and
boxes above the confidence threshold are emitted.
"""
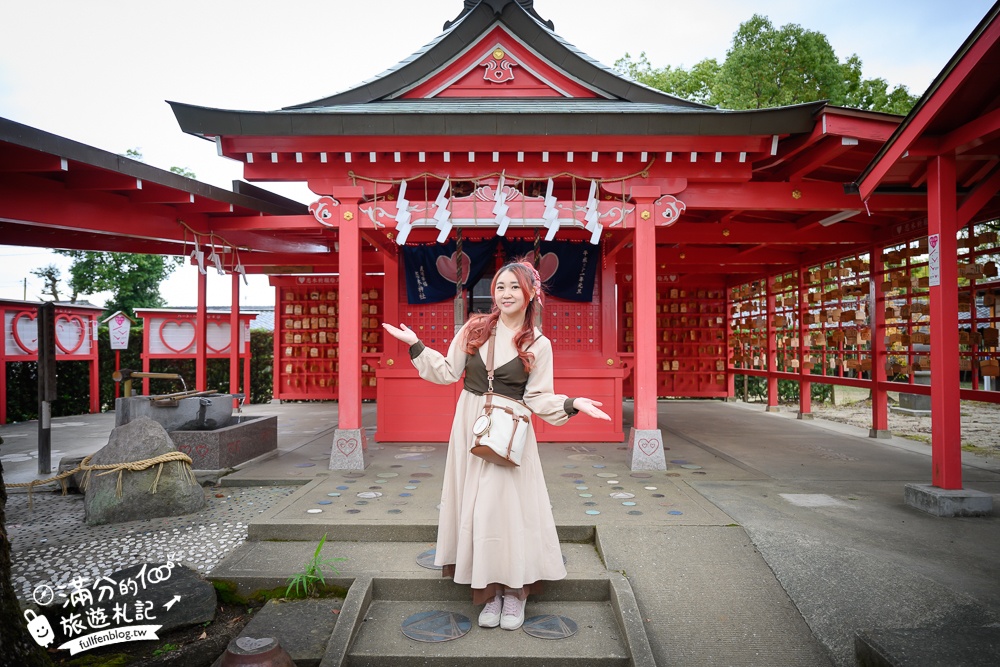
[171,0,992,470]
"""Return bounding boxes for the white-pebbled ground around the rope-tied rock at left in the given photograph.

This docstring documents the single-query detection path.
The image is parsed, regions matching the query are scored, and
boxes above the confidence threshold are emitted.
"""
[6,486,301,600]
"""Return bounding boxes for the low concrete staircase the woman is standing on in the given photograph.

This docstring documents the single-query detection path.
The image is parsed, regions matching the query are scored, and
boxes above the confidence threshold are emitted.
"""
[210,521,654,667]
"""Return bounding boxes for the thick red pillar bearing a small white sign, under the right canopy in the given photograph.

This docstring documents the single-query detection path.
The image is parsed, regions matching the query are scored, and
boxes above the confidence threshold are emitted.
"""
[927,155,962,489]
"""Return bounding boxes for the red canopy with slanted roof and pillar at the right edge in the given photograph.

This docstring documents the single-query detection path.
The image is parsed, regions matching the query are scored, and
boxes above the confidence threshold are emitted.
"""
[855,5,1000,500]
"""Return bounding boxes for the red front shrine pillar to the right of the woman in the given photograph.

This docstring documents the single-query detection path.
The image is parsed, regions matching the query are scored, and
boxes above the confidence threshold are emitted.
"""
[632,192,659,430]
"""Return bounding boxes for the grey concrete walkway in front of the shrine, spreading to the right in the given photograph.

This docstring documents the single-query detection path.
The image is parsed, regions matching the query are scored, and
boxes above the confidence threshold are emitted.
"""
[0,401,1000,666]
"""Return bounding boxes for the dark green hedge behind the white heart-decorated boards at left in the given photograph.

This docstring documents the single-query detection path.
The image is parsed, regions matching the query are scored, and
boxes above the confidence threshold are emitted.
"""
[6,327,274,423]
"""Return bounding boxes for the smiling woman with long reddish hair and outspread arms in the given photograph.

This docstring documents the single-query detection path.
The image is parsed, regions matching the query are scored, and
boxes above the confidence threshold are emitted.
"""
[382,261,611,630]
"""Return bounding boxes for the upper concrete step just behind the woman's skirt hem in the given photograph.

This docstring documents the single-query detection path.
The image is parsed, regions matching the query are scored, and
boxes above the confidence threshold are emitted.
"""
[208,541,608,599]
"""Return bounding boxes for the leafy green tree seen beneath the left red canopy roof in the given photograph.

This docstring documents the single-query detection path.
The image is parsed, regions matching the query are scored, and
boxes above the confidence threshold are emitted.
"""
[56,250,182,315]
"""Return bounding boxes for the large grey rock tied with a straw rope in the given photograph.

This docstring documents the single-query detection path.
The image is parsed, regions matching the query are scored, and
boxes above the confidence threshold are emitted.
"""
[84,417,205,526]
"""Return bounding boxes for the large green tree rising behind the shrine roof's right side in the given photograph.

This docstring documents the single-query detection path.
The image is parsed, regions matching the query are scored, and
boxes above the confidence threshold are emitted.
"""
[615,14,917,114]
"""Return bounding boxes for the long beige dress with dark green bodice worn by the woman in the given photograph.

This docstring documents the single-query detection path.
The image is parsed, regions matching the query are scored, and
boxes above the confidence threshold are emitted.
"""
[410,322,576,604]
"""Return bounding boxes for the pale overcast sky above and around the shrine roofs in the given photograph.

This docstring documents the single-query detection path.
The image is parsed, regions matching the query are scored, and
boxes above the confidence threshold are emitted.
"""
[0,0,992,306]
